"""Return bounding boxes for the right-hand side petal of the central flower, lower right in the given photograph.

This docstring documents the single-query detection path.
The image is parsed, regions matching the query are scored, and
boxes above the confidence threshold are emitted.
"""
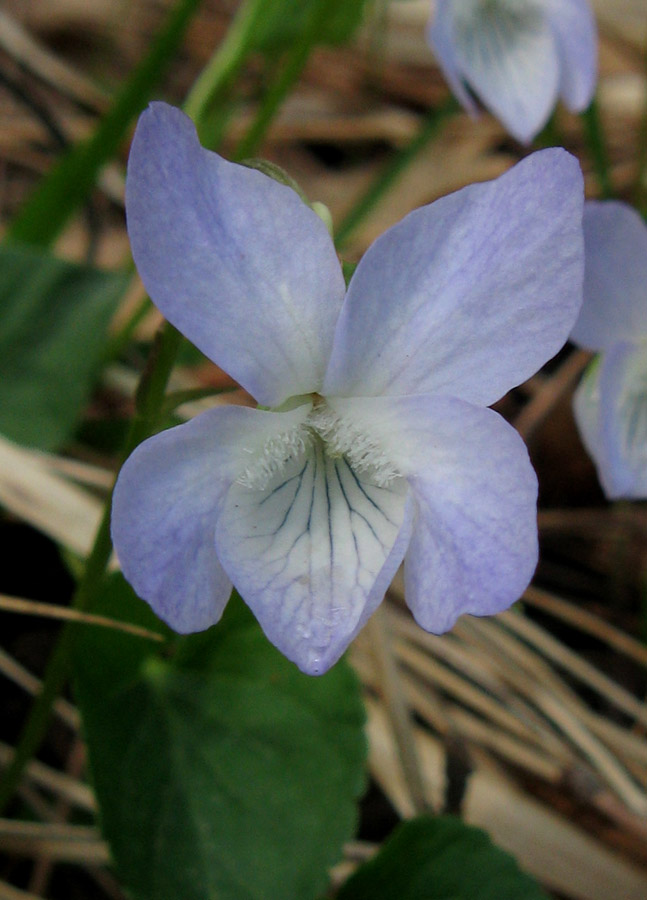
[329,397,538,633]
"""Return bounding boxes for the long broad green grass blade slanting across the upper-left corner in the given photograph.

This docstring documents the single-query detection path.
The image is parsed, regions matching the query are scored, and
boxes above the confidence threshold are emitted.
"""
[6,0,200,247]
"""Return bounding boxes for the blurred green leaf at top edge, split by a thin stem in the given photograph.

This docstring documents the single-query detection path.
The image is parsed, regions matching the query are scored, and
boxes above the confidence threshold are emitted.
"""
[255,0,367,53]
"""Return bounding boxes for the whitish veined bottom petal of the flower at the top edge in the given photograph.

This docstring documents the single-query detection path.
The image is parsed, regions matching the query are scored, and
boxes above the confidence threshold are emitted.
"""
[432,0,560,143]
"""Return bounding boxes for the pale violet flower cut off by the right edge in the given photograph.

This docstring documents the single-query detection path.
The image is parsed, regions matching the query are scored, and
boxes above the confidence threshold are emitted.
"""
[571,200,647,498]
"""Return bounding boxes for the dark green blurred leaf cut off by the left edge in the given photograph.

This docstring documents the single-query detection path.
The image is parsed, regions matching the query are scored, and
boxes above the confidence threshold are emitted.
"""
[0,245,128,450]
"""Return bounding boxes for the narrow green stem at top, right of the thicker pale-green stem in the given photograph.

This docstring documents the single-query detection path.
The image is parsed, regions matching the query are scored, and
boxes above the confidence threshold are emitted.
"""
[234,0,330,159]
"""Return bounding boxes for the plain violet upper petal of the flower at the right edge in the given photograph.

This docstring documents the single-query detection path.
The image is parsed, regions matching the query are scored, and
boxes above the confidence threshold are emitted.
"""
[571,200,647,350]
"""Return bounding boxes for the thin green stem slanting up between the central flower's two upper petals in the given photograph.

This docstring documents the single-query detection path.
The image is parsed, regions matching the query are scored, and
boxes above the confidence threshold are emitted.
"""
[335,97,459,248]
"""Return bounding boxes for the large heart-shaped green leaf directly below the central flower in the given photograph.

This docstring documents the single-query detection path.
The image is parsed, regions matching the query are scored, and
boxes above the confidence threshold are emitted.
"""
[75,577,365,900]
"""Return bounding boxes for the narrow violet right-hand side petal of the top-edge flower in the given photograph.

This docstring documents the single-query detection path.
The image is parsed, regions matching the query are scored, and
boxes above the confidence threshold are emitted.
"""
[543,0,598,112]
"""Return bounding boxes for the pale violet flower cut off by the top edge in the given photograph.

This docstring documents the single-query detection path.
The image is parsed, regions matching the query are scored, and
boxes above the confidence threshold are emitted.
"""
[428,0,597,143]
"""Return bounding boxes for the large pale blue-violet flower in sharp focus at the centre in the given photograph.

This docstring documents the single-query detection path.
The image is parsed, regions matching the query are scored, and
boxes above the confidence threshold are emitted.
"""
[113,103,583,674]
